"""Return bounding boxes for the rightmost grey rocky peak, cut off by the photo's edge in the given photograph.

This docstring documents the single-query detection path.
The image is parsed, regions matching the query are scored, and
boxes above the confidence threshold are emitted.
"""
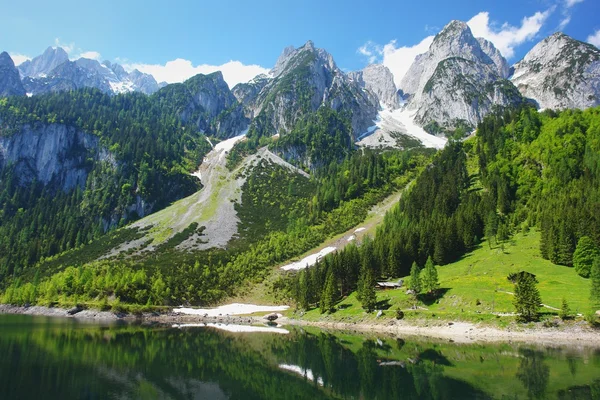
[511,32,600,109]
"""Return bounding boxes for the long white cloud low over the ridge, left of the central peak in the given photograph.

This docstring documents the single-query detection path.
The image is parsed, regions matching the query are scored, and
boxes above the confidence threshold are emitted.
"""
[123,58,269,88]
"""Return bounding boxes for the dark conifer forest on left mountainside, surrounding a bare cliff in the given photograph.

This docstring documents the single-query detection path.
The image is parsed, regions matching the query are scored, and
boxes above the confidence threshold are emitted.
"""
[0,89,210,282]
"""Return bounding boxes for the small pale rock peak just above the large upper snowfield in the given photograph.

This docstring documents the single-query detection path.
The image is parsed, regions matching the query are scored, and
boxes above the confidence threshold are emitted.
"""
[348,64,400,110]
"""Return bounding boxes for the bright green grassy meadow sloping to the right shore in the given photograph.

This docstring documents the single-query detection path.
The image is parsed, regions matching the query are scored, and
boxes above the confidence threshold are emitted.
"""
[296,231,590,325]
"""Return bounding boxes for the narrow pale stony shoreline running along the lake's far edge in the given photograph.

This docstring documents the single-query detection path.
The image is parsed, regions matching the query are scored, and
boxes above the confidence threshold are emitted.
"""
[0,304,600,348]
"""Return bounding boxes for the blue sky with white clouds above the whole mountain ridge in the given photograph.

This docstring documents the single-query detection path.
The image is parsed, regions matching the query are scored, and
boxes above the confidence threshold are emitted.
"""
[0,0,600,85]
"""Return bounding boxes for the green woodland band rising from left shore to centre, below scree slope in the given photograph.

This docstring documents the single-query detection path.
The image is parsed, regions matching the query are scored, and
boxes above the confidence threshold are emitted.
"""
[3,115,434,309]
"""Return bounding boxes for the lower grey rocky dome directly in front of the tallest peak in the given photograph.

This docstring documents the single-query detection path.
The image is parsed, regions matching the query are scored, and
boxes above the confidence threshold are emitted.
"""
[415,57,523,133]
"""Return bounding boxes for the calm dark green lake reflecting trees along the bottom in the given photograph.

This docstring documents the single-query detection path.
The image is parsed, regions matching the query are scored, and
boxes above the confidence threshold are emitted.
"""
[0,315,600,400]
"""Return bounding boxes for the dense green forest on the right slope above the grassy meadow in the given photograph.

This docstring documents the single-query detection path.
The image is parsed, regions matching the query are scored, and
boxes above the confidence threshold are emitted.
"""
[288,107,600,311]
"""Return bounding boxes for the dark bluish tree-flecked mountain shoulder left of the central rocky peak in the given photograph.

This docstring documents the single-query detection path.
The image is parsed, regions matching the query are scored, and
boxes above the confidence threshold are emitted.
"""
[155,71,250,138]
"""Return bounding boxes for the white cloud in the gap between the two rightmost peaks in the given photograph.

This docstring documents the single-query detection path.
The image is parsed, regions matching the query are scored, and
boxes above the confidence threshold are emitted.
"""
[467,7,554,59]
